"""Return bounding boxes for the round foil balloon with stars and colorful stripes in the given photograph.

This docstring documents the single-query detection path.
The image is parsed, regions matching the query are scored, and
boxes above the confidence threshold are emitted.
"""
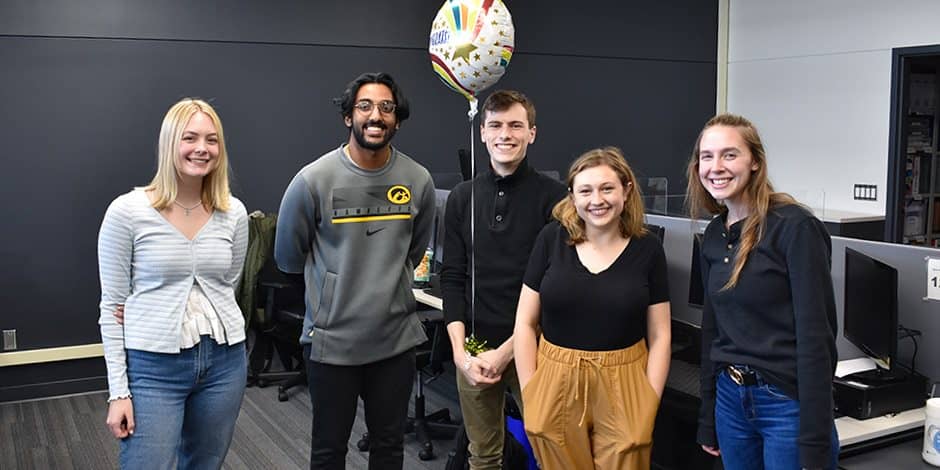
[428,0,515,119]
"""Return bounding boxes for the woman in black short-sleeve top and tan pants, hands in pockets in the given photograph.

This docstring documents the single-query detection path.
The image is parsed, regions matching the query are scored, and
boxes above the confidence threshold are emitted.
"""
[513,147,670,469]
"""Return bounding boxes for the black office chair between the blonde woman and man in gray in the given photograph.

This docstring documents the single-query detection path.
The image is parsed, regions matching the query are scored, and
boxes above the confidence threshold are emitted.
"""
[248,253,307,401]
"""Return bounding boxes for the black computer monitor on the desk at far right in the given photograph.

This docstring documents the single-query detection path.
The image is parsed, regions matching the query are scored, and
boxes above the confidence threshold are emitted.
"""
[842,247,898,378]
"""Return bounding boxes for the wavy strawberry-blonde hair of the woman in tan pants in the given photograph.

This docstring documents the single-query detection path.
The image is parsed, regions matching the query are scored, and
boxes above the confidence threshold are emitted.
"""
[552,147,647,245]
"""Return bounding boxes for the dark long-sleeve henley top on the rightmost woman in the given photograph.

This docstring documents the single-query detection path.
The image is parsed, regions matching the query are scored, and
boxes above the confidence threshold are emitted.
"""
[698,205,837,468]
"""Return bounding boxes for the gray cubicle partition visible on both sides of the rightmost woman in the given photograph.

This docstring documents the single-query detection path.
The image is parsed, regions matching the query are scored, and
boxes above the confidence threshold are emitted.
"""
[647,215,940,381]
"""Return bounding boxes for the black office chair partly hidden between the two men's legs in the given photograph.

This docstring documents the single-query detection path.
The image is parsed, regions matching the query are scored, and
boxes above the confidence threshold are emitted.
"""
[356,310,463,460]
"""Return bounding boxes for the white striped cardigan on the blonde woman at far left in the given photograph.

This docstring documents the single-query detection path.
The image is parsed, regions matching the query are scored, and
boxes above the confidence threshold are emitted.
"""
[98,188,248,400]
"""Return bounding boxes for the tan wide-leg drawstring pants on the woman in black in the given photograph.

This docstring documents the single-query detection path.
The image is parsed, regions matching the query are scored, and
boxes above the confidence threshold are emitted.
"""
[522,337,659,470]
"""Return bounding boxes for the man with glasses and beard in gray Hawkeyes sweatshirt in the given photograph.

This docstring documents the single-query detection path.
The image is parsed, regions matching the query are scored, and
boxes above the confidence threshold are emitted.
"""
[274,73,435,469]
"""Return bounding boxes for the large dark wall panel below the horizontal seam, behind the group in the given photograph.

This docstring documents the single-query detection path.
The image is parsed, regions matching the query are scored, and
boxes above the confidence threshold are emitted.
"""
[0,38,714,348]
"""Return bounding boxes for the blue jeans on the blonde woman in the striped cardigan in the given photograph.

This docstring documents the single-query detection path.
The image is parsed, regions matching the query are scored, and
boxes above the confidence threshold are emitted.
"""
[120,336,248,469]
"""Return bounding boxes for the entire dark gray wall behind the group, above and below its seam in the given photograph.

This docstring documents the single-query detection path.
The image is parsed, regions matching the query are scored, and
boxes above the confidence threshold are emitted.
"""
[0,0,717,398]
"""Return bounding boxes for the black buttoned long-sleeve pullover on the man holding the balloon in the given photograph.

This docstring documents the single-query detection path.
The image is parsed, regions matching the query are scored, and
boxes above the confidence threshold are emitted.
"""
[441,157,567,348]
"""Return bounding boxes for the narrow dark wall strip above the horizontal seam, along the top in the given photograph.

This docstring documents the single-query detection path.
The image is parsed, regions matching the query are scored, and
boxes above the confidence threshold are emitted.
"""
[0,0,718,62]
